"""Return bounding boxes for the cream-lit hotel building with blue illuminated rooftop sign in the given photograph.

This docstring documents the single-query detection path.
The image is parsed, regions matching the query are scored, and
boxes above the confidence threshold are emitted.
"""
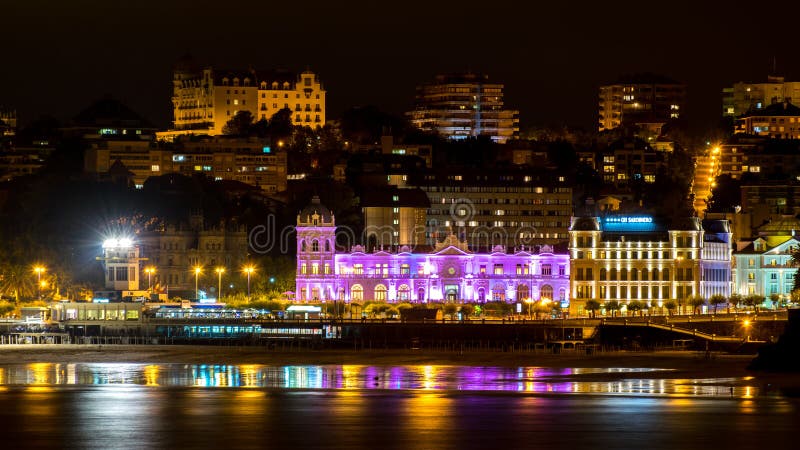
[569,215,732,315]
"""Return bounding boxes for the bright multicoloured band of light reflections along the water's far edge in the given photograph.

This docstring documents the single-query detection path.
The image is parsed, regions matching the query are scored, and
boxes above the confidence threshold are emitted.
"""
[0,363,759,398]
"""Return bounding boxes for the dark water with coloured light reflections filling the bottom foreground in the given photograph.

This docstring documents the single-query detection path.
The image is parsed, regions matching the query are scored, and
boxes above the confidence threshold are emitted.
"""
[0,363,800,450]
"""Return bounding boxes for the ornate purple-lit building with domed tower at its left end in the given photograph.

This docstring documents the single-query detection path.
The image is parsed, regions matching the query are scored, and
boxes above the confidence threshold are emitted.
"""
[296,197,570,307]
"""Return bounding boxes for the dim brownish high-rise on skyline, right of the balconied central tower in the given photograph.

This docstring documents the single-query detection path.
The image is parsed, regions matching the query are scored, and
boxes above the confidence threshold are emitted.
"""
[599,73,686,136]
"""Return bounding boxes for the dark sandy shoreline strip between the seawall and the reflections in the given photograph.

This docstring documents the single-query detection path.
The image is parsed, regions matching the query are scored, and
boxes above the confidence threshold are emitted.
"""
[0,344,800,390]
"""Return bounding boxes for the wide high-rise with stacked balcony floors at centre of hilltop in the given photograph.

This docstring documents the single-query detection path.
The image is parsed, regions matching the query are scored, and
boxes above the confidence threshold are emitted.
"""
[406,73,519,143]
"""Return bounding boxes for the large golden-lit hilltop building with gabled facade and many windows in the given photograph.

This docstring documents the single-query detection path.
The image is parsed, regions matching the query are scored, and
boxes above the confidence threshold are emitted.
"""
[171,63,325,136]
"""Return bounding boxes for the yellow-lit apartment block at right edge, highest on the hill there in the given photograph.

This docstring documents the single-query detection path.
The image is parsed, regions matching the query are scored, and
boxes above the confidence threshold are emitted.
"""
[722,76,800,117]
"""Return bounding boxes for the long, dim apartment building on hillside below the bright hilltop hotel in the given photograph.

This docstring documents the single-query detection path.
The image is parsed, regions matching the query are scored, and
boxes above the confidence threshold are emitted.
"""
[84,136,287,194]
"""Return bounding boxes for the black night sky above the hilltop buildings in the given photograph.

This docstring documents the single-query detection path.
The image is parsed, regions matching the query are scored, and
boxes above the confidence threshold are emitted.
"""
[0,0,800,134]
